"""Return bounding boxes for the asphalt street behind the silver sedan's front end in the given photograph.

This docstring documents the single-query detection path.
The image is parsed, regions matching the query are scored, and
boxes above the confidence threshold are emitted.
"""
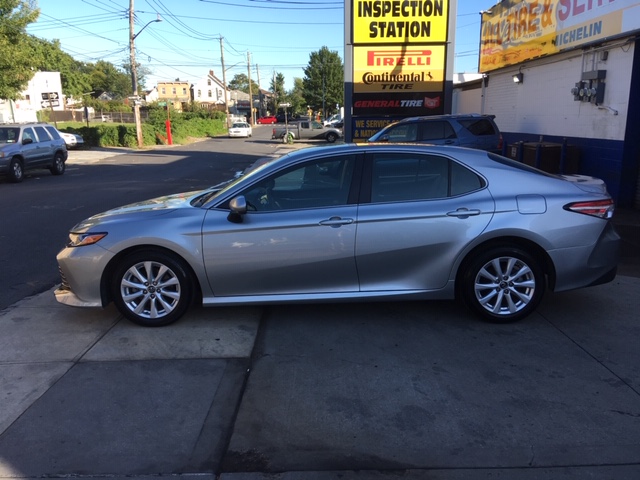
[0,126,281,310]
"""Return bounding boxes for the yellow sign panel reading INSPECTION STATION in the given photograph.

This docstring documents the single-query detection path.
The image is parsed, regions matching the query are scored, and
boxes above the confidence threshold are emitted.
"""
[353,0,449,45]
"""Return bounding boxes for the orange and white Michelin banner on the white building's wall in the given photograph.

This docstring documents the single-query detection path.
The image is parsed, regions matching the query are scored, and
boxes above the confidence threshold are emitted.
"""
[479,0,640,72]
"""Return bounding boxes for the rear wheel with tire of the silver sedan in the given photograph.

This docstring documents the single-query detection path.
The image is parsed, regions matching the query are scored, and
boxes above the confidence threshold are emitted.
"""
[460,246,545,323]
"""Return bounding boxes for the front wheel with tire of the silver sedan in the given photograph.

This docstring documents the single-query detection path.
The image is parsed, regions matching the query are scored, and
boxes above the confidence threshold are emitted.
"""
[111,250,194,327]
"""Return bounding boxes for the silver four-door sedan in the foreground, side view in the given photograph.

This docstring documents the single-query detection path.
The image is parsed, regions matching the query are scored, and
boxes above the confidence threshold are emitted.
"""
[55,144,620,326]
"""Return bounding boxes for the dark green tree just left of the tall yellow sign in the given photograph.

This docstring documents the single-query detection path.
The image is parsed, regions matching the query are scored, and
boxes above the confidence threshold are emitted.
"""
[302,47,344,118]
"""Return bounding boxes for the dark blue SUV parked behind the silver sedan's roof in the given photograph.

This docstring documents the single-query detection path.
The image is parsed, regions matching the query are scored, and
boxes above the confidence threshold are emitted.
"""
[369,113,502,153]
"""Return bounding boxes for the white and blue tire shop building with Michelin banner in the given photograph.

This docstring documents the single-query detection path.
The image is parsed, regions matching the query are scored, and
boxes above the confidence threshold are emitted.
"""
[464,0,640,208]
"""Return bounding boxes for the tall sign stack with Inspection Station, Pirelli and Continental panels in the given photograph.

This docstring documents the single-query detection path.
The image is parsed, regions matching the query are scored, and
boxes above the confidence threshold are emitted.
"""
[345,0,455,141]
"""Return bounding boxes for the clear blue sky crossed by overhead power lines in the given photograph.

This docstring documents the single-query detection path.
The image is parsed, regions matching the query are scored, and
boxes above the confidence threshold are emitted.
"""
[27,0,498,90]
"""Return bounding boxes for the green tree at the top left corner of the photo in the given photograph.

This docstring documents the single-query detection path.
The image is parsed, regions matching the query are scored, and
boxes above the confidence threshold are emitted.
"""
[0,0,40,100]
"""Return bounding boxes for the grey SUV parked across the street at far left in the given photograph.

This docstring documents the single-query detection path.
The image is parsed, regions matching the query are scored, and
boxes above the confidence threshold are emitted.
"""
[0,123,68,183]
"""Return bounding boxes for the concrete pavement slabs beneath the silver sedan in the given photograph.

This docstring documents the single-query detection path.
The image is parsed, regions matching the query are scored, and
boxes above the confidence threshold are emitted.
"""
[0,143,640,480]
